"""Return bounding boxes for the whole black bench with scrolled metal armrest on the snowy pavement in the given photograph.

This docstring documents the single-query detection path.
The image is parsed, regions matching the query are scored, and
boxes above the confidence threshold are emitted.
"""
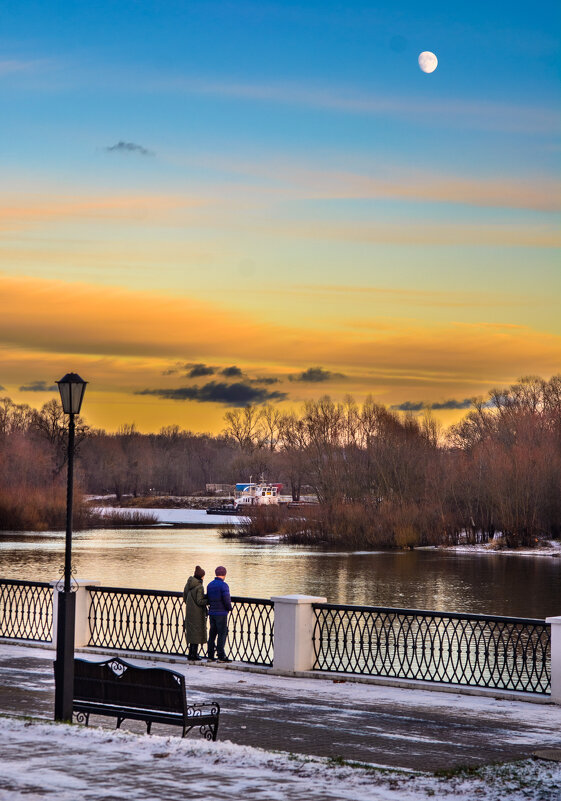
[69,657,220,740]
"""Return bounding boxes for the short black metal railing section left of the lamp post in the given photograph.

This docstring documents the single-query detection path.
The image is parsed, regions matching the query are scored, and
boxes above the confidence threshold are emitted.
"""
[0,579,53,642]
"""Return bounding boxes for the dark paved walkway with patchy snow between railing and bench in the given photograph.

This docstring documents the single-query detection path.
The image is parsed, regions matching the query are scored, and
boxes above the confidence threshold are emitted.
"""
[0,645,561,771]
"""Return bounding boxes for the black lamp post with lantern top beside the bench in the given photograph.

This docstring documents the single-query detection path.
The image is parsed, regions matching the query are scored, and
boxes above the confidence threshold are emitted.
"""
[55,373,87,721]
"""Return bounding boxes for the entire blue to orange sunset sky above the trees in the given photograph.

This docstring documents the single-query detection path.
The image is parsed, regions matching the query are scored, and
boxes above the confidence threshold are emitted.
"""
[0,0,561,433]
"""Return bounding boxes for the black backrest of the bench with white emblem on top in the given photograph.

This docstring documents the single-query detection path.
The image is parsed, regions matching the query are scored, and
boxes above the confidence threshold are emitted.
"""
[74,658,186,712]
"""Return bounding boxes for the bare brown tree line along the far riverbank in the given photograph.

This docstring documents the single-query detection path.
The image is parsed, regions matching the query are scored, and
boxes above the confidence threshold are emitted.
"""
[0,375,561,547]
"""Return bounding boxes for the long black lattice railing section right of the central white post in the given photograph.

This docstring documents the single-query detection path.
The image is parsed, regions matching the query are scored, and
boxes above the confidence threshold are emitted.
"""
[313,604,551,693]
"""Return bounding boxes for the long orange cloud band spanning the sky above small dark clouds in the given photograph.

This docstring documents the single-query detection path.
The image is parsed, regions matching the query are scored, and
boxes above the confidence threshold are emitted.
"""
[0,276,561,381]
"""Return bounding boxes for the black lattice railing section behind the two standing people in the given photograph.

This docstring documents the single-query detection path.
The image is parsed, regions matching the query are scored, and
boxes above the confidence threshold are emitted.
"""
[87,586,274,665]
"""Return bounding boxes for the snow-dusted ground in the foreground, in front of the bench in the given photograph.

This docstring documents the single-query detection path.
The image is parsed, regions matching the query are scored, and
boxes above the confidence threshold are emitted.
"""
[0,717,561,801]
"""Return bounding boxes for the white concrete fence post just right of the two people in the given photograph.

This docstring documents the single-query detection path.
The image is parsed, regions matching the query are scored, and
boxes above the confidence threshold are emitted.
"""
[271,595,327,673]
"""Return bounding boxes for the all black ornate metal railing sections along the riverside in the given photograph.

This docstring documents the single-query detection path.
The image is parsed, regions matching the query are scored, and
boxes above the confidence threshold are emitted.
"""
[0,579,557,694]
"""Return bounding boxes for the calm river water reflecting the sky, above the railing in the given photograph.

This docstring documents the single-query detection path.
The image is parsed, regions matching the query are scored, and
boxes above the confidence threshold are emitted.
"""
[0,528,561,618]
